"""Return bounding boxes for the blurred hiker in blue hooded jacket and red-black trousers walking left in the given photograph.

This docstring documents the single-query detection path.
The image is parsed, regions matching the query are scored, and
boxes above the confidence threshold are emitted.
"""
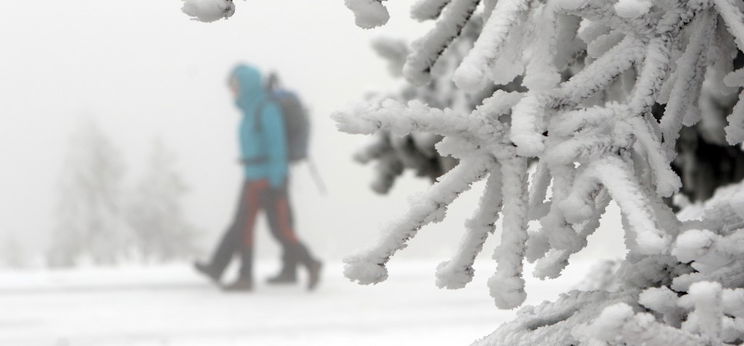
[195,65,322,291]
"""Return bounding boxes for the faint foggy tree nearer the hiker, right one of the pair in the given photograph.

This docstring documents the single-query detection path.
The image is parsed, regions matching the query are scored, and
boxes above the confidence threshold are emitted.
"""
[126,140,198,262]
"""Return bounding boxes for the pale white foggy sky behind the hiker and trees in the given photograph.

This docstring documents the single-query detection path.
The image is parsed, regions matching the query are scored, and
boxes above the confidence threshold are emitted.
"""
[0,0,628,264]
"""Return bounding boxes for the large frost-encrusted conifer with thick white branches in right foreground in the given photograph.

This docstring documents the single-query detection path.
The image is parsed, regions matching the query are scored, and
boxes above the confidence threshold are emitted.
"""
[336,0,744,345]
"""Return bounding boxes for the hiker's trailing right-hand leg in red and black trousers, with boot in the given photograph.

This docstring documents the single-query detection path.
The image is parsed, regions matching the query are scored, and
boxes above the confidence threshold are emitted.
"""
[262,184,321,289]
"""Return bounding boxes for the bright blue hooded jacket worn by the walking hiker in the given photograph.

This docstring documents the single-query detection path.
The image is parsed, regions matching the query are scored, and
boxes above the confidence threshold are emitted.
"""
[232,65,289,188]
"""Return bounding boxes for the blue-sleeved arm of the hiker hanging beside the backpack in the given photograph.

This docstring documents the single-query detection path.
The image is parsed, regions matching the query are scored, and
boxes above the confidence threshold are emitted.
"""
[261,103,289,188]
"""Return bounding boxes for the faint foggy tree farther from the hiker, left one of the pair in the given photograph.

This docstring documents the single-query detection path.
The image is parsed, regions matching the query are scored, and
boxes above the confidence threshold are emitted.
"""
[47,121,134,267]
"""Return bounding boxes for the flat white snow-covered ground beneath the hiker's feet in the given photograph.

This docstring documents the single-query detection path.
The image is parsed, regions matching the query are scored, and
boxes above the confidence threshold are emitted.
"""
[0,261,587,346]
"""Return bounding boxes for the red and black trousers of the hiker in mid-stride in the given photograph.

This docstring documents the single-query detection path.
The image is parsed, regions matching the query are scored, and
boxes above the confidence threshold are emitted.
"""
[210,180,315,279]
